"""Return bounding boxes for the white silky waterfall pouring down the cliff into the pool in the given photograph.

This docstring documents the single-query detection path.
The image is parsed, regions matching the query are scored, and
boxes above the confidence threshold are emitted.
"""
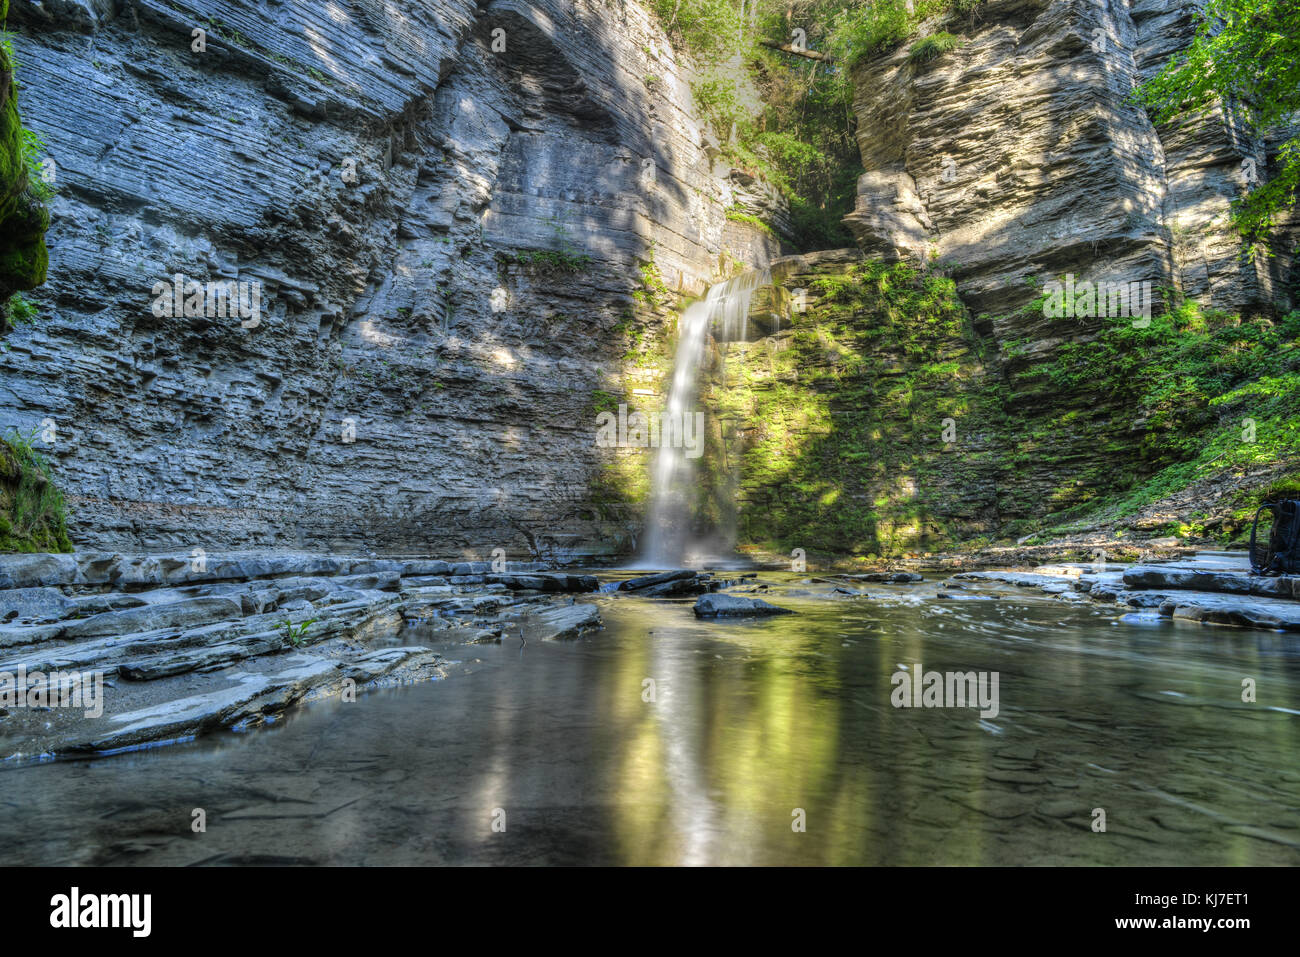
[642,269,772,568]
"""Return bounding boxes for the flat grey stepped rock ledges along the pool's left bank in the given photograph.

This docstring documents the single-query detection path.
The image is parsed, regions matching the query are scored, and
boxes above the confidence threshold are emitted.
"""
[0,553,602,762]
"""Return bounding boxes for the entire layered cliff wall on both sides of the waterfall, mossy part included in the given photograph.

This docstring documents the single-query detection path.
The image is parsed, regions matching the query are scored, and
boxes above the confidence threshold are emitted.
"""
[0,0,1294,559]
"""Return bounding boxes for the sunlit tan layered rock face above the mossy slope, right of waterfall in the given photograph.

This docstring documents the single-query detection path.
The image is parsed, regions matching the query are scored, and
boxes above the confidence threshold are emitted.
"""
[845,0,1290,321]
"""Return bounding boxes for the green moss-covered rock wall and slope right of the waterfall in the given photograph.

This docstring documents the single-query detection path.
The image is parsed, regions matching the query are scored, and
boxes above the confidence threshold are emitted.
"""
[697,260,1300,558]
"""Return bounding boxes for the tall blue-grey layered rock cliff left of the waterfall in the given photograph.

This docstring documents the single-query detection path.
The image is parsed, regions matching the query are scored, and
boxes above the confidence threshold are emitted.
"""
[0,0,774,558]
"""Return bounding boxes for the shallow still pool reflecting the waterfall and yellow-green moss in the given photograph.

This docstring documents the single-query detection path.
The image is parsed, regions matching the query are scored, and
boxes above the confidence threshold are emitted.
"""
[0,573,1300,865]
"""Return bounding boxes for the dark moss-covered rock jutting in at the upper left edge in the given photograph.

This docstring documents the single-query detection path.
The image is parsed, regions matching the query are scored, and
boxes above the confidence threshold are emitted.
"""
[0,0,49,303]
